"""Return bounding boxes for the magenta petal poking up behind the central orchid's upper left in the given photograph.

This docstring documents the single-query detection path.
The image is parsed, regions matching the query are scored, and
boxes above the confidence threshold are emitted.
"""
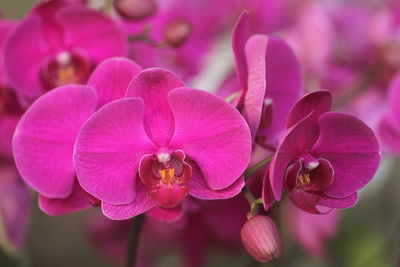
[88,57,141,108]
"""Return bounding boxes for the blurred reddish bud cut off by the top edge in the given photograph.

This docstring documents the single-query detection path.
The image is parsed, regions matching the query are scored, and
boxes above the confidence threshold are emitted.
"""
[114,0,157,20]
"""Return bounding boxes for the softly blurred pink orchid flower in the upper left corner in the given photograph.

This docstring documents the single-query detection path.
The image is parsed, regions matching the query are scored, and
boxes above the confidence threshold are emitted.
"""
[4,0,127,103]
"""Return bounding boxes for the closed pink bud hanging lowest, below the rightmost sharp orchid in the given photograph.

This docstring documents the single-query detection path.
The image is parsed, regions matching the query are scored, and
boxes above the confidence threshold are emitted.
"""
[240,215,282,262]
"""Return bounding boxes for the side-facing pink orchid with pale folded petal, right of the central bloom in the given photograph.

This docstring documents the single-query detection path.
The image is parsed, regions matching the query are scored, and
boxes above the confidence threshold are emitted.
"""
[218,12,303,149]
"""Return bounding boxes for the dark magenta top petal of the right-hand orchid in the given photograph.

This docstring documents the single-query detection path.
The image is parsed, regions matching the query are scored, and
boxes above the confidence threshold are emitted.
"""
[286,91,332,128]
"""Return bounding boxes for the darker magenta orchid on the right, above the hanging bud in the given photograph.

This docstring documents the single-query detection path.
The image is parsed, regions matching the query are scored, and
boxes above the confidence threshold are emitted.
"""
[263,91,380,213]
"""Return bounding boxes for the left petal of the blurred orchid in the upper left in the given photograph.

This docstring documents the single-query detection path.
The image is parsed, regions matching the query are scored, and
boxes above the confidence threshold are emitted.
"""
[4,15,50,98]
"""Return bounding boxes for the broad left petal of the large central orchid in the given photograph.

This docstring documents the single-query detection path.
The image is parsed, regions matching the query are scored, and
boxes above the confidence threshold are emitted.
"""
[74,98,156,205]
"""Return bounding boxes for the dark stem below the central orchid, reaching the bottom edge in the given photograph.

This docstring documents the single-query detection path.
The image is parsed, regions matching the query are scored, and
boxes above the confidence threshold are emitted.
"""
[126,214,144,267]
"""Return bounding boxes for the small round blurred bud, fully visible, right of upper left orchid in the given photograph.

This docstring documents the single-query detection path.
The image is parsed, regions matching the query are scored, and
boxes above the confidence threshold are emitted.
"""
[164,19,192,47]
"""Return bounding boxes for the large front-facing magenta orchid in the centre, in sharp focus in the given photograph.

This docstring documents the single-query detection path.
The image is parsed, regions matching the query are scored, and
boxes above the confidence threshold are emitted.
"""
[74,68,251,219]
